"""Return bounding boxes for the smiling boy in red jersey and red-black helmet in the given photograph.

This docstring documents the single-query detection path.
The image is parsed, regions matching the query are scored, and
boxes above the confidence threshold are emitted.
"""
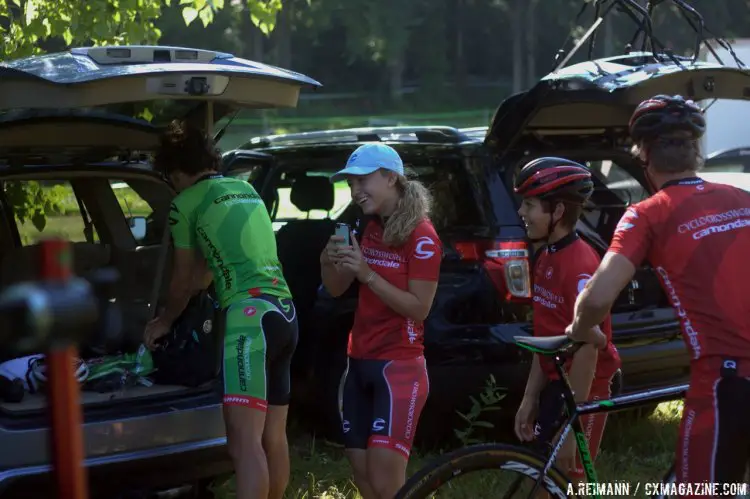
[515,157,620,480]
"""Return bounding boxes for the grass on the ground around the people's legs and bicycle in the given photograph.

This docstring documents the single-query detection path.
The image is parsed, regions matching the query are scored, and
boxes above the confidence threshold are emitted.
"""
[209,402,682,499]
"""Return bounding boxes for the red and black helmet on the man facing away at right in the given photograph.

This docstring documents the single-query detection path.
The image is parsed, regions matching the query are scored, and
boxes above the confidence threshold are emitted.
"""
[629,95,706,142]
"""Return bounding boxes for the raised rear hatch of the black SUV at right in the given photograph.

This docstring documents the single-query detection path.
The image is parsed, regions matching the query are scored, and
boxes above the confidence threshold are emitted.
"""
[485,52,750,155]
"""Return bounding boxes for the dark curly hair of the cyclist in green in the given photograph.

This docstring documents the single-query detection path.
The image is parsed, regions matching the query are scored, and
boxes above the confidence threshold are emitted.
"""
[154,120,221,175]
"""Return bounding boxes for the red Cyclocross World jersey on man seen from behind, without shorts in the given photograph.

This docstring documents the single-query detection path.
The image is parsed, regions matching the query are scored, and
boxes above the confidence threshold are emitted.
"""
[609,178,750,361]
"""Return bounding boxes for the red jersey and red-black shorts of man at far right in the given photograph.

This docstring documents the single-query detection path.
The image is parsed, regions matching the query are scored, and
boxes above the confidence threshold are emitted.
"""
[609,178,750,486]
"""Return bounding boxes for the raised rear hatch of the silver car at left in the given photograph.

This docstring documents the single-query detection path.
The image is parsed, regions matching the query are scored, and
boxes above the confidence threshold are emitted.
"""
[0,46,321,115]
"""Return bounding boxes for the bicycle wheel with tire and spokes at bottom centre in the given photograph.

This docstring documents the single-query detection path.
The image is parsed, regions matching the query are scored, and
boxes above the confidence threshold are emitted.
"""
[394,444,576,499]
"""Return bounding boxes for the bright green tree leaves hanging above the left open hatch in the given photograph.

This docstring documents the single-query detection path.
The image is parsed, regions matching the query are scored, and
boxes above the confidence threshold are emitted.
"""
[0,0,281,60]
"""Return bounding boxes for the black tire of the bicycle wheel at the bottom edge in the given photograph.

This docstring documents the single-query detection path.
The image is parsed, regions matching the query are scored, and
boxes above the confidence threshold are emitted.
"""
[394,444,576,499]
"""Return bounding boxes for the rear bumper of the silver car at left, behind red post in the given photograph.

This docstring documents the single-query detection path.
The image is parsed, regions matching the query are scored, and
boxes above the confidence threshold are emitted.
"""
[0,404,231,499]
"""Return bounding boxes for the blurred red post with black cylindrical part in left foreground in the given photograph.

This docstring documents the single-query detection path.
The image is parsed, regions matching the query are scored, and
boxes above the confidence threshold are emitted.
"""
[0,239,119,499]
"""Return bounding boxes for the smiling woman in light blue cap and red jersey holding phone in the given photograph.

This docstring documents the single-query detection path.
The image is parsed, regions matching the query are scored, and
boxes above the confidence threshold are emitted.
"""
[320,143,442,499]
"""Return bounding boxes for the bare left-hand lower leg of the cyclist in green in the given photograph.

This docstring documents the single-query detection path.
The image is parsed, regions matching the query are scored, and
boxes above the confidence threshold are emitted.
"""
[224,405,268,499]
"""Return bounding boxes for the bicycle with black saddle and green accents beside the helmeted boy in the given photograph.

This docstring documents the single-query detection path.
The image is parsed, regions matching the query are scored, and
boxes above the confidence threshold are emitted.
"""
[394,335,689,499]
